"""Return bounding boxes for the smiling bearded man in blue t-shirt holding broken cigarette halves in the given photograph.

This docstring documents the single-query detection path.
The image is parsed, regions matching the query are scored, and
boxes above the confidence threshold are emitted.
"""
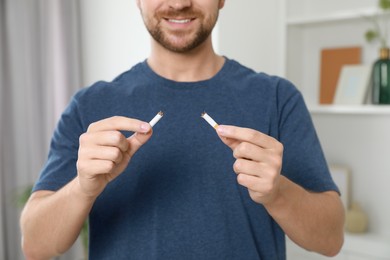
[21,0,344,259]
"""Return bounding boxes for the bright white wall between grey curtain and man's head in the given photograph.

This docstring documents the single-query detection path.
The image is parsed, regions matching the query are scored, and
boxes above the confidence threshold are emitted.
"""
[80,0,149,85]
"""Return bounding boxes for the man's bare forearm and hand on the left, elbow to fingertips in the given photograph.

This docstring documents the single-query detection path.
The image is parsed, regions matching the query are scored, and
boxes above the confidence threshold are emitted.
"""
[20,116,152,259]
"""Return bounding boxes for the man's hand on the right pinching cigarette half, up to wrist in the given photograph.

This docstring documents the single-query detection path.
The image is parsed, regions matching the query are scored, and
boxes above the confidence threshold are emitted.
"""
[217,125,283,204]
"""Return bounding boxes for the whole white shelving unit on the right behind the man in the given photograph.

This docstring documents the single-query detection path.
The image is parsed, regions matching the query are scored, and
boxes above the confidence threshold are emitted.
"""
[280,0,390,260]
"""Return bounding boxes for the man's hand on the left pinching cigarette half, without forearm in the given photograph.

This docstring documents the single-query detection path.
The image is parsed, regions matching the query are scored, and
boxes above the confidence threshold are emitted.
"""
[77,116,152,198]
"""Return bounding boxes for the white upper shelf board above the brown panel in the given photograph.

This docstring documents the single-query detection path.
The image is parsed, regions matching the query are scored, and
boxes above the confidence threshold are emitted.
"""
[287,8,383,26]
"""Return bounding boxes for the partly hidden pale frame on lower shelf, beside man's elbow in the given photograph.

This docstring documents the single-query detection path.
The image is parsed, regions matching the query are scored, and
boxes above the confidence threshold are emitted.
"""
[329,165,351,210]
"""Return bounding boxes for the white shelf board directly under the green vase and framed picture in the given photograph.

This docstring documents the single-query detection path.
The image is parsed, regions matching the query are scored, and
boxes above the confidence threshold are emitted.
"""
[309,105,390,115]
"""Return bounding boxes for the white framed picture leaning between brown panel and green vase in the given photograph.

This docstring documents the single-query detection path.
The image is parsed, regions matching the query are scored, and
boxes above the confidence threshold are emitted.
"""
[333,65,371,105]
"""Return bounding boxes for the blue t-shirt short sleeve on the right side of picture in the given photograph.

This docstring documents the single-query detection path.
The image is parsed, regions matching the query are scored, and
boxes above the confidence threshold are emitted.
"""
[278,80,338,192]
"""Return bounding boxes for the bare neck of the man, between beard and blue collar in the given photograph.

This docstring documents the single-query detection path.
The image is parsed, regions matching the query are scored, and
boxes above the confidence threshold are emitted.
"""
[148,37,225,82]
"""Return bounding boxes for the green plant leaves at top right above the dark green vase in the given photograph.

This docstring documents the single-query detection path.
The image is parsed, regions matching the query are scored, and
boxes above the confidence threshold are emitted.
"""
[365,0,390,48]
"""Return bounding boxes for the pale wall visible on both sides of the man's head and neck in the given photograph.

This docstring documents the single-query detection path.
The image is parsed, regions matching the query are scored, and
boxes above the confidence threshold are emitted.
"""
[80,0,281,85]
